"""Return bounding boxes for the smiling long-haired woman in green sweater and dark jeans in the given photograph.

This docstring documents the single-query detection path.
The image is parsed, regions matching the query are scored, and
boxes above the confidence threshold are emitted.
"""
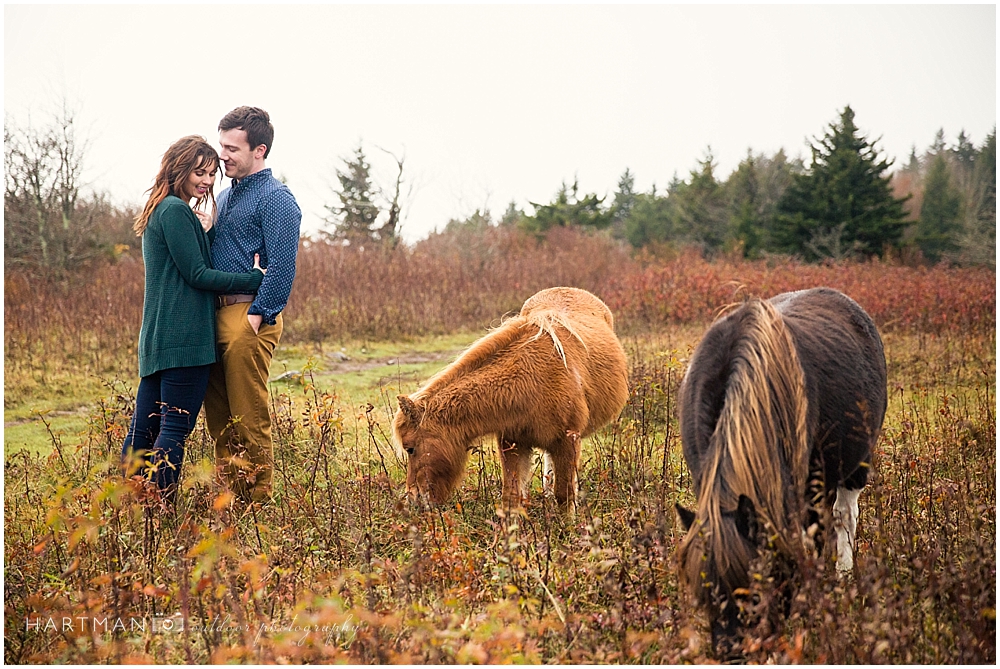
[122,135,264,499]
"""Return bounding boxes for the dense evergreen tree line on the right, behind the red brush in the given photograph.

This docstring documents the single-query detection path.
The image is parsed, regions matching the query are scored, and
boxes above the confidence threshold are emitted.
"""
[449,106,996,265]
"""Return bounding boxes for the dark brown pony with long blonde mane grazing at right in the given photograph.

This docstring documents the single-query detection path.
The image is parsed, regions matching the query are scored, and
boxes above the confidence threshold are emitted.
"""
[677,288,886,655]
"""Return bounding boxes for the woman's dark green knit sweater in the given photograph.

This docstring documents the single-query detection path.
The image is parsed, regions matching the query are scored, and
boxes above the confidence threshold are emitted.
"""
[139,195,264,376]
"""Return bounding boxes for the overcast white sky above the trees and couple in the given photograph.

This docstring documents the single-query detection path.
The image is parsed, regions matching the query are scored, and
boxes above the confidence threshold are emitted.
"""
[4,5,996,241]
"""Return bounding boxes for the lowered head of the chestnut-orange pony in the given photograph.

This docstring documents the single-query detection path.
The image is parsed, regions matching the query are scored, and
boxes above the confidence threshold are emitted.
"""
[392,395,469,504]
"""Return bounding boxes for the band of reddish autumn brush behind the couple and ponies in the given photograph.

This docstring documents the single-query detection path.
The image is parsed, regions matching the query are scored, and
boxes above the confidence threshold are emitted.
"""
[4,228,996,357]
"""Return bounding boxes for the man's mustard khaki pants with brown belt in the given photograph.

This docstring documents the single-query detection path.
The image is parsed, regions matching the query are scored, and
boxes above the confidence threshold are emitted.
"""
[205,302,282,502]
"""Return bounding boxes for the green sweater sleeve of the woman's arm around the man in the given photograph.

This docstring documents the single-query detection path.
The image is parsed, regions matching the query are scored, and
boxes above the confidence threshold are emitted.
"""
[162,204,264,293]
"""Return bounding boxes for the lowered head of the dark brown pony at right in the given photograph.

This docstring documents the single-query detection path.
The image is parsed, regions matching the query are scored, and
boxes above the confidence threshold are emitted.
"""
[677,495,760,659]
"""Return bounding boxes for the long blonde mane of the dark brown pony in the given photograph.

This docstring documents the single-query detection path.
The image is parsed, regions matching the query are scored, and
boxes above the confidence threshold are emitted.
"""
[680,299,809,590]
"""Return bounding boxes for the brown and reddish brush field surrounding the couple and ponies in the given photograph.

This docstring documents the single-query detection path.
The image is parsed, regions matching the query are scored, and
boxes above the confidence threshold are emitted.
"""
[4,228,996,663]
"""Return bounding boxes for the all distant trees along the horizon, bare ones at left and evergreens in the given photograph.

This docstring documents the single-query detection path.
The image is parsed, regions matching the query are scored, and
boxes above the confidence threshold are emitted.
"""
[4,105,996,274]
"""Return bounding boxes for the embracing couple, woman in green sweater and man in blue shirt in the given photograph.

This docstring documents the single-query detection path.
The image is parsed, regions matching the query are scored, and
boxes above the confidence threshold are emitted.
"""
[122,107,302,502]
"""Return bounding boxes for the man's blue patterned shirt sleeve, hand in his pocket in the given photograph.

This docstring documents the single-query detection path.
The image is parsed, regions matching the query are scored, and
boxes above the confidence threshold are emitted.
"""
[247,188,302,325]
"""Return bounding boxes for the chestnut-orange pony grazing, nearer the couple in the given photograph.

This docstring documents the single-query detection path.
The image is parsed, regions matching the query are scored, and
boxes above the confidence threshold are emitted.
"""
[392,288,628,514]
